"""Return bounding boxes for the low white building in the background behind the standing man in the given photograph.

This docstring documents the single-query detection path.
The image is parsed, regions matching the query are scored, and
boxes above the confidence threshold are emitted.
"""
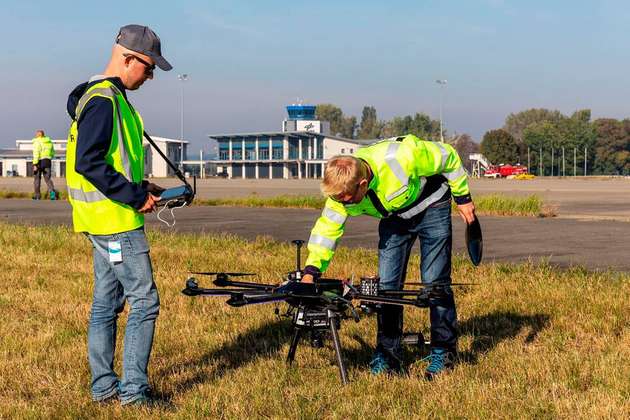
[0,137,188,178]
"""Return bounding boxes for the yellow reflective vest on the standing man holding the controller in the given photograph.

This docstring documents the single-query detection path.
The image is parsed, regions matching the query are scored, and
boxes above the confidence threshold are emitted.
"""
[66,80,144,235]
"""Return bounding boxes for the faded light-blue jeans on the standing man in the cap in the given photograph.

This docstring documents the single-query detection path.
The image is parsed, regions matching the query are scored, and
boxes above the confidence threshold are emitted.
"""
[87,228,160,404]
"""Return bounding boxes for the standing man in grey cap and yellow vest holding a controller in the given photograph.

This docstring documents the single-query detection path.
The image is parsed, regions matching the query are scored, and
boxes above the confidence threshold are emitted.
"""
[66,25,172,405]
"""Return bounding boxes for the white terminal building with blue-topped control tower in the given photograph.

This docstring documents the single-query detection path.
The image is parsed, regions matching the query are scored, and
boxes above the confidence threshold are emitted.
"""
[209,105,375,179]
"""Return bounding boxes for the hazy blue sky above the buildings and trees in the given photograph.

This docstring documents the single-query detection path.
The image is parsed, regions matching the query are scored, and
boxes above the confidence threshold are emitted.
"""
[0,0,630,150]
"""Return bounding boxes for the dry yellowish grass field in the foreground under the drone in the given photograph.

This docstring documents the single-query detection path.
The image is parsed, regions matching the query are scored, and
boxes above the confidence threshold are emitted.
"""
[0,223,630,419]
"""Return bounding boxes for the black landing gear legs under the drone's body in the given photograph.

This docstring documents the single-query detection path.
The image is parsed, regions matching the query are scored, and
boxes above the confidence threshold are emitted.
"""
[287,306,348,385]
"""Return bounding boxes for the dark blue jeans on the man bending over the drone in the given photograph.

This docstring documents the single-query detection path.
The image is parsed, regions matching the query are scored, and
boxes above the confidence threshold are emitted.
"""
[377,200,457,359]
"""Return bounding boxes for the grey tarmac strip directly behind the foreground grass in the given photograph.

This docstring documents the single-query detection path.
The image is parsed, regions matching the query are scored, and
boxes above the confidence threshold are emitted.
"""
[0,198,630,271]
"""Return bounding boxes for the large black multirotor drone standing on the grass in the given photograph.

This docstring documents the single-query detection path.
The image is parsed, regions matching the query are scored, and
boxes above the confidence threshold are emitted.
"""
[182,230,481,385]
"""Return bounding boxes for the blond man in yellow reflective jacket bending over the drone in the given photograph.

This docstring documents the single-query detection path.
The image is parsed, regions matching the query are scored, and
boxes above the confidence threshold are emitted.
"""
[303,135,475,379]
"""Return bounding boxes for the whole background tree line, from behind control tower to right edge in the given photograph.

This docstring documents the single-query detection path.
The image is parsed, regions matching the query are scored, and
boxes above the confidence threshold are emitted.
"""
[316,104,630,175]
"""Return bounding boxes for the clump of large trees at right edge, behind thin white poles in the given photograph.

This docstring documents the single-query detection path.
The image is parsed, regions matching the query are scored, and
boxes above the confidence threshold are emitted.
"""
[481,108,630,175]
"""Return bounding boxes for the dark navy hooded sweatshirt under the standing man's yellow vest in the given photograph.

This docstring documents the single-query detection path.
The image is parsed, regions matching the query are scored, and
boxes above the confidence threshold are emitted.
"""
[67,77,147,209]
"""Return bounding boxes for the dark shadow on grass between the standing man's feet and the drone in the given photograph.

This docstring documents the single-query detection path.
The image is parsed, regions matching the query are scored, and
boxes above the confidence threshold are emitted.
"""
[157,319,293,401]
